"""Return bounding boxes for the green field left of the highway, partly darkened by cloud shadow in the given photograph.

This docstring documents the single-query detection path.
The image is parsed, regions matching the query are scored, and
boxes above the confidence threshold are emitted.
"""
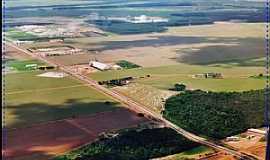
[5,71,120,128]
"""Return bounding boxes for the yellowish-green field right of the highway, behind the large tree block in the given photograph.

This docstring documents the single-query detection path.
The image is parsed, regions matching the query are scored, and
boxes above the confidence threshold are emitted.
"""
[89,64,265,91]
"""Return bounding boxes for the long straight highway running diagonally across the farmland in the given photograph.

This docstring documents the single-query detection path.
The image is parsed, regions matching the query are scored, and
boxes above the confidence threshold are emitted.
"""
[6,42,262,160]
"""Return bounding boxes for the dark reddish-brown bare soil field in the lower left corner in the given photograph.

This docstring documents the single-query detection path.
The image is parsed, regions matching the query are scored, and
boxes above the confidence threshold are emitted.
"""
[2,109,148,160]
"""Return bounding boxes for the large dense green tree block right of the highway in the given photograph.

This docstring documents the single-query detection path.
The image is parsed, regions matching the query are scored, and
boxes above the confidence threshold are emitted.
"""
[164,90,264,139]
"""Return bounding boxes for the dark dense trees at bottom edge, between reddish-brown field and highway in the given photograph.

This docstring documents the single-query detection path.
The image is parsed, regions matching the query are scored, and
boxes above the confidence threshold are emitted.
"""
[56,128,198,160]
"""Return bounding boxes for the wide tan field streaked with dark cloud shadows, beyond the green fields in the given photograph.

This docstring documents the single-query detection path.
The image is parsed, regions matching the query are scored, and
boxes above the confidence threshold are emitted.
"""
[19,23,265,67]
